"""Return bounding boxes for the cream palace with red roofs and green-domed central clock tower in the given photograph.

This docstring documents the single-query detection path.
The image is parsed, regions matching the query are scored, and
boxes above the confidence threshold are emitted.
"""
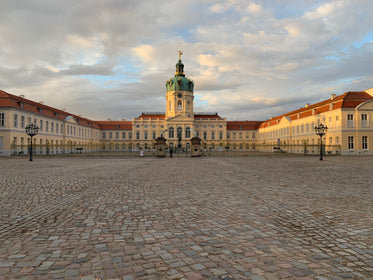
[0,54,373,156]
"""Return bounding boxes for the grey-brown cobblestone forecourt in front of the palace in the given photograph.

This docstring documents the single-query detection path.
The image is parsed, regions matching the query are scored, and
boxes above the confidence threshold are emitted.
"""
[0,156,373,280]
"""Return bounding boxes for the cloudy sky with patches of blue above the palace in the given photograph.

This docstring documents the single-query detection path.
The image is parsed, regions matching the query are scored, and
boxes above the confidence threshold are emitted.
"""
[0,0,373,120]
